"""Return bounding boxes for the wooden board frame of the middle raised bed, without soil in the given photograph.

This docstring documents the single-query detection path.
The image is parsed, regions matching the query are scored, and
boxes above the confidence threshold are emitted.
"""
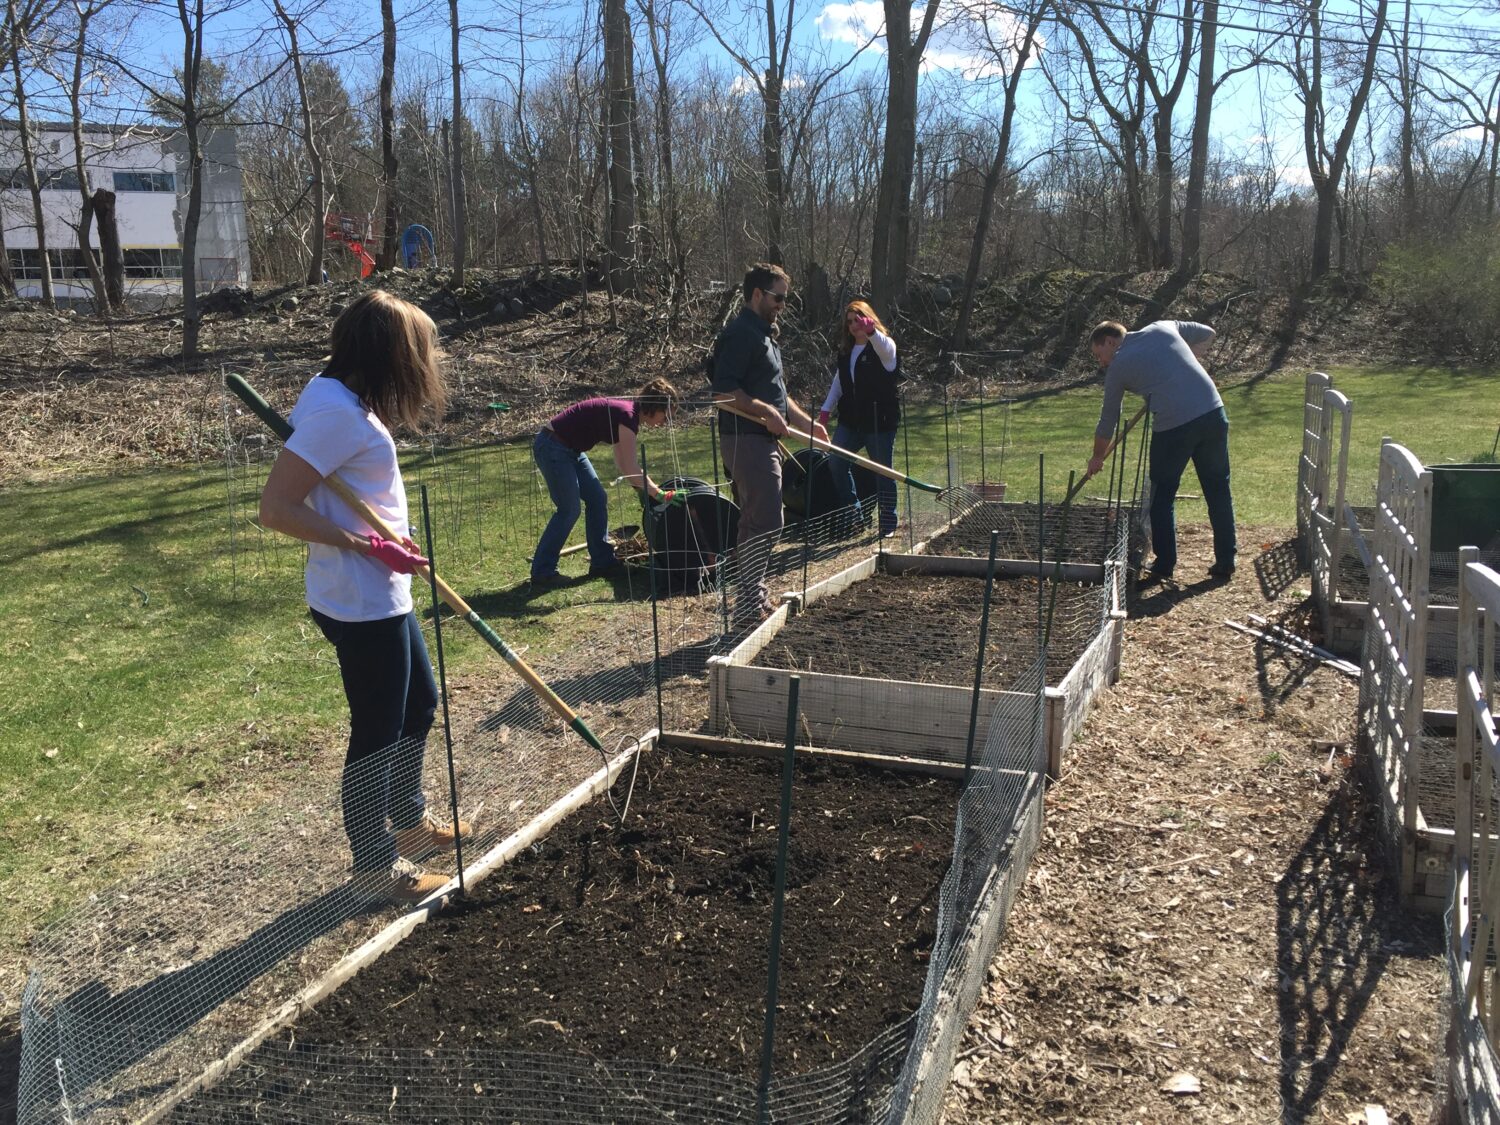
[708,554,1125,779]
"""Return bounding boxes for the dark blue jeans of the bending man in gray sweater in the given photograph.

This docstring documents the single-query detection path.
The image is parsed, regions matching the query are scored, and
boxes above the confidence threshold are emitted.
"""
[1151,407,1236,575]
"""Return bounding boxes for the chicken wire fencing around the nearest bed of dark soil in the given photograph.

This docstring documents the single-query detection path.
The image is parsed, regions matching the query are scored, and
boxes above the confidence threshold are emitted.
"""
[20,519,1043,1122]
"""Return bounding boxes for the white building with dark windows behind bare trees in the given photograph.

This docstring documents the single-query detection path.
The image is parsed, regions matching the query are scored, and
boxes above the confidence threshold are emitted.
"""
[0,122,251,305]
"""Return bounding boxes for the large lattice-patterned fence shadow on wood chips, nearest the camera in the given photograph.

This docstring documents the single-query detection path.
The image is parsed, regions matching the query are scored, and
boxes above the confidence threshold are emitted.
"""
[1277,773,1443,1124]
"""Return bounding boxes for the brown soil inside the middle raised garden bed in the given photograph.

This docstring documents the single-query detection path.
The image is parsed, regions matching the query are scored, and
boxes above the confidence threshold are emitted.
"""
[755,575,1104,687]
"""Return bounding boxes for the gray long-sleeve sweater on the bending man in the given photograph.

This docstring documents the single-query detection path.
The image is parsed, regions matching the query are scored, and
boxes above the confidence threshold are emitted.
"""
[1094,321,1224,438]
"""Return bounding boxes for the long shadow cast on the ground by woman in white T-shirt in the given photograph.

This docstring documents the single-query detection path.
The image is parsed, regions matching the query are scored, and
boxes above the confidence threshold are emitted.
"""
[16,882,417,1121]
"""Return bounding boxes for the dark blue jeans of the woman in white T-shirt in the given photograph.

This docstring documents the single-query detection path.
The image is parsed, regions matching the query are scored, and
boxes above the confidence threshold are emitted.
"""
[309,609,438,872]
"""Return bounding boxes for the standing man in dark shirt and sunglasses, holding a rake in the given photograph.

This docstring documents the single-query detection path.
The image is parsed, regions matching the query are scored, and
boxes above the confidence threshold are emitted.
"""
[711,266,828,621]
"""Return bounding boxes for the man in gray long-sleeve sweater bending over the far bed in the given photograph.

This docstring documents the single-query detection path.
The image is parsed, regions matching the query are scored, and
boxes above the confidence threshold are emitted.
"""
[1089,321,1236,581]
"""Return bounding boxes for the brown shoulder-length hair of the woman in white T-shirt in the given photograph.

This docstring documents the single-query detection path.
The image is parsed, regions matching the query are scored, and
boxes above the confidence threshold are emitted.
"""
[323,290,447,426]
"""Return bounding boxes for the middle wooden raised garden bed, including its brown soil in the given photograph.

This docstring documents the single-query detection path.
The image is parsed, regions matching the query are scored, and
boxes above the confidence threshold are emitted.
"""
[710,555,1124,777]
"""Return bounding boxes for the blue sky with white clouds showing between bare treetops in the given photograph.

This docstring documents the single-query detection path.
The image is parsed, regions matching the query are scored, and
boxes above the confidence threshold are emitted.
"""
[64,0,1500,192]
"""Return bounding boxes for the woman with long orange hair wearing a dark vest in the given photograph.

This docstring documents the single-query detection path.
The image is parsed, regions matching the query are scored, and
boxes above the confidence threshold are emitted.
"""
[818,302,902,536]
